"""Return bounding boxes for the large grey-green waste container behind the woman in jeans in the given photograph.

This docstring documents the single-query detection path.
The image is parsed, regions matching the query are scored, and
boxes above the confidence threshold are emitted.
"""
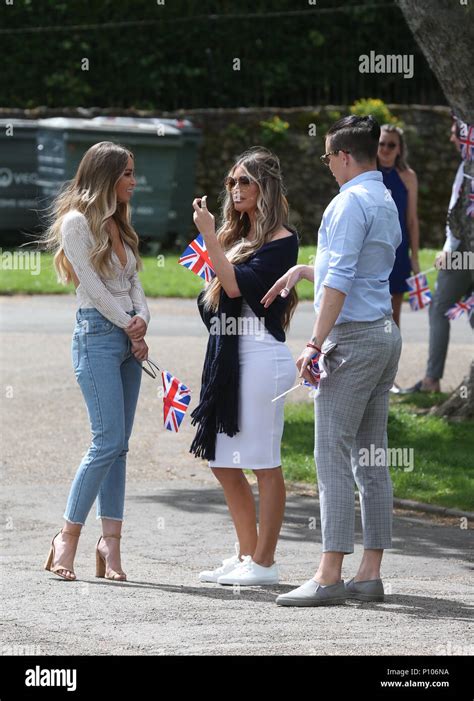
[37,117,200,249]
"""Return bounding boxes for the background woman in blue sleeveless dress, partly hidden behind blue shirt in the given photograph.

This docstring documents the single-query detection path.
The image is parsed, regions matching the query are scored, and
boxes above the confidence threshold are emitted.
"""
[377,124,420,336]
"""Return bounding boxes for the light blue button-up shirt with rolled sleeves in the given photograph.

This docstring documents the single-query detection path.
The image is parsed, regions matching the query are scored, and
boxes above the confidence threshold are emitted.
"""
[314,170,402,324]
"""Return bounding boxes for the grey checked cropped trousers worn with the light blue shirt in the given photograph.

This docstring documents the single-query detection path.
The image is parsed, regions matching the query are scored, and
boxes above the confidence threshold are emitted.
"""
[314,316,402,553]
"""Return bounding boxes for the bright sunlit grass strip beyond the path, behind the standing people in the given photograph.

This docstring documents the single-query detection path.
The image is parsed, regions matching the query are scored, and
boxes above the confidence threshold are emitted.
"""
[0,246,437,299]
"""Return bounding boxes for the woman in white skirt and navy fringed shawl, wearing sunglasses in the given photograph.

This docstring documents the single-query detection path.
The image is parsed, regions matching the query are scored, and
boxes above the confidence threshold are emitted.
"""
[191,147,298,585]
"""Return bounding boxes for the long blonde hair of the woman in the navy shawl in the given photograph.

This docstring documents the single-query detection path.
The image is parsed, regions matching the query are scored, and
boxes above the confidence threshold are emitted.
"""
[203,146,298,330]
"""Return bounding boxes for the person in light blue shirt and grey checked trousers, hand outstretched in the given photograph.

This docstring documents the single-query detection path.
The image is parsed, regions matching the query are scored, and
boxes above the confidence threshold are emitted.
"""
[262,116,402,606]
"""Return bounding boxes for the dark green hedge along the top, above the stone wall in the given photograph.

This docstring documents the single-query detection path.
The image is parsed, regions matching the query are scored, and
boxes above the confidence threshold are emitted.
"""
[0,0,444,110]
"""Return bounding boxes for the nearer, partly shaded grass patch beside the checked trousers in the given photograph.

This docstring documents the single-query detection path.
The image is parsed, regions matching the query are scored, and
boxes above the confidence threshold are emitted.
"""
[282,394,474,511]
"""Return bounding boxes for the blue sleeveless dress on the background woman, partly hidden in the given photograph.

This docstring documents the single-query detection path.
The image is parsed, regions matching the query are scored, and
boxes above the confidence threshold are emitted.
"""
[380,168,411,294]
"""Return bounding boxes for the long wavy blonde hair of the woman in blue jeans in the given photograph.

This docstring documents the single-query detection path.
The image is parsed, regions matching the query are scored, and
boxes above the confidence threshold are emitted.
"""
[39,141,143,285]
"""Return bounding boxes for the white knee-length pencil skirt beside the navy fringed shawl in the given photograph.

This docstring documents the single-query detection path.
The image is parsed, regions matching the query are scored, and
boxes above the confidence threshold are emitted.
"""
[209,302,297,470]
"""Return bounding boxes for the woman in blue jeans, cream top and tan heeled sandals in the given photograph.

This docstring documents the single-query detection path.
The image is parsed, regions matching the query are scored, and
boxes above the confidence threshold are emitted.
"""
[43,141,150,580]
